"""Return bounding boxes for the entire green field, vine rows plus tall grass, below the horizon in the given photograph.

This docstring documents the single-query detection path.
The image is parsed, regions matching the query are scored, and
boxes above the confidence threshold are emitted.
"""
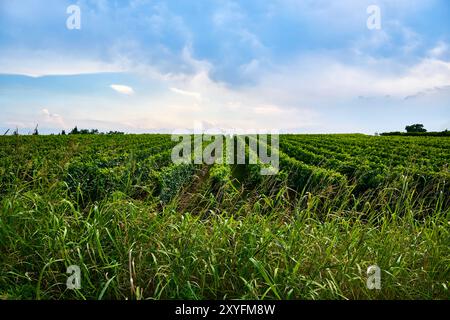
[0,135,450,299]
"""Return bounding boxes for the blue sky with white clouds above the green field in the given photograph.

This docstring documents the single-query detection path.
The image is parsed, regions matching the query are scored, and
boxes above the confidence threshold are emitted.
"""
[0,0,450,134]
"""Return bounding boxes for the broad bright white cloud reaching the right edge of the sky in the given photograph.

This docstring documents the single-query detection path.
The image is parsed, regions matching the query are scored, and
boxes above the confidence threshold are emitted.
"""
[250,56,450,106]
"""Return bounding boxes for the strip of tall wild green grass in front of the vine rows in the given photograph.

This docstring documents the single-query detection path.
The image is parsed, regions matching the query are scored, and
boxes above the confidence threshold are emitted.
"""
[0,182,450,299]
